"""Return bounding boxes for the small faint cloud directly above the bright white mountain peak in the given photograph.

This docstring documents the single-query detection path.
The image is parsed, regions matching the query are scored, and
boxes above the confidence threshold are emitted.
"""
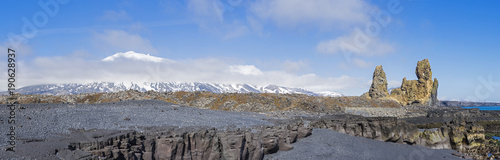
[94,30,158,53]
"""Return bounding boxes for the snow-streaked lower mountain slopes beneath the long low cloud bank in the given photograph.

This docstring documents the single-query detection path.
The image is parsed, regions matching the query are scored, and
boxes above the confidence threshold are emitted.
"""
[6,82,343,97]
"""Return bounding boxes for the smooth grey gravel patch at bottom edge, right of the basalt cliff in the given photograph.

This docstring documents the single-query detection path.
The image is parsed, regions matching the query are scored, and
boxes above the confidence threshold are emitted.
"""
[264,129,461,160]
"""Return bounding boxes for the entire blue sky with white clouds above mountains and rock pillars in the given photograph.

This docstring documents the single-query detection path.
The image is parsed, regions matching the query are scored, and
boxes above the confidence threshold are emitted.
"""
[0,0,500,101]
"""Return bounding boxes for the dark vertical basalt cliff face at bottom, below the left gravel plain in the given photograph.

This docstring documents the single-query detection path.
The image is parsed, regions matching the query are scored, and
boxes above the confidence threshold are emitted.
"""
[56,121,312,160]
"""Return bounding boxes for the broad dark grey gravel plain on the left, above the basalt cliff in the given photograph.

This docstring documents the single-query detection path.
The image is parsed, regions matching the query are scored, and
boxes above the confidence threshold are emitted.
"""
[0,100,272,146]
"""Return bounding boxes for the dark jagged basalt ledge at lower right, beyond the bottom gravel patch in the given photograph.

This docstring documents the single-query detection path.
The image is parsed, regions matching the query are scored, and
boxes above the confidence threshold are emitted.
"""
[309,116,494,159]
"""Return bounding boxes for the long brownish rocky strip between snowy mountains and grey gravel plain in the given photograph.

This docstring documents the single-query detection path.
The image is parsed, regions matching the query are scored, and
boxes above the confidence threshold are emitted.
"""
[0,90,401,113]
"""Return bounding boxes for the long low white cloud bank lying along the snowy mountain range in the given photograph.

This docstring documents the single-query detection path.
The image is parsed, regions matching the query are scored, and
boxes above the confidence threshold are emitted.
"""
[0,50,367,94]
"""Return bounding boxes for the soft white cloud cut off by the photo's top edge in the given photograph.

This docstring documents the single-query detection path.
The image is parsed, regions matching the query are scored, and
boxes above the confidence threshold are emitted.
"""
[250,0,374,29]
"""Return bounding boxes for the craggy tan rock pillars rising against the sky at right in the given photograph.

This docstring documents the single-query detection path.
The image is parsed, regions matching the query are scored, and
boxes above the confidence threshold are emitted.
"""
[362,59,439,106]
